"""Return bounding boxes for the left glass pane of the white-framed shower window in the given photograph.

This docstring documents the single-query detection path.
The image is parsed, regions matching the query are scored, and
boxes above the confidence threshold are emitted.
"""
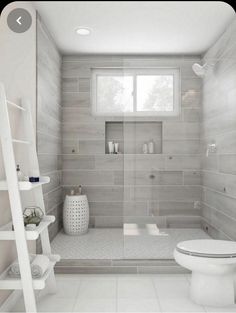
[96,75,133,113]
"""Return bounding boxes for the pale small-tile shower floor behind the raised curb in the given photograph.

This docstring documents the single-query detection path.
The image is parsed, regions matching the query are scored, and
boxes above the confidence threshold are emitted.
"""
[51,224,210,259]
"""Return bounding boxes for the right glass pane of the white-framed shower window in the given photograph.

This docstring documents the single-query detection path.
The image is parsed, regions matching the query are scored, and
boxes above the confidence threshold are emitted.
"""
[137,75,174,112]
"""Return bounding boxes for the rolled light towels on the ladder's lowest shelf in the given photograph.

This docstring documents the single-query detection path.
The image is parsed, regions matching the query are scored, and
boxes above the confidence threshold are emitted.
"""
[8,254,50,278]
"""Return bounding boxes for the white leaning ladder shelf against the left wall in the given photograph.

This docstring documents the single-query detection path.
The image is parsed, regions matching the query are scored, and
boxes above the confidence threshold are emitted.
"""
[0,83,60,312]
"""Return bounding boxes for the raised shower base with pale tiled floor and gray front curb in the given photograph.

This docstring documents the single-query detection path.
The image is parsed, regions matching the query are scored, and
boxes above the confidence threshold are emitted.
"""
[52,228,210,274]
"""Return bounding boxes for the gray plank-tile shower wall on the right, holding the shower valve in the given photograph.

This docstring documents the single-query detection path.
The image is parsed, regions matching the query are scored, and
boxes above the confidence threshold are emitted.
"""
[201,21,236,240]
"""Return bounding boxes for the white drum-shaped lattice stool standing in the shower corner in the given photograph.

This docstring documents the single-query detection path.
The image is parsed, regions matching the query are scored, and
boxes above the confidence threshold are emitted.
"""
[63,195,89,236]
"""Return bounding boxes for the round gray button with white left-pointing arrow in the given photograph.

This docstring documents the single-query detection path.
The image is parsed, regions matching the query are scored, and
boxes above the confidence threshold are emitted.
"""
[7,8,32,33]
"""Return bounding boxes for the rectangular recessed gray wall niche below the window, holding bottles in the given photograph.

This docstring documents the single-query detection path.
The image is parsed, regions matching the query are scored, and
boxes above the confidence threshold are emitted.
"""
[105,122,162,154]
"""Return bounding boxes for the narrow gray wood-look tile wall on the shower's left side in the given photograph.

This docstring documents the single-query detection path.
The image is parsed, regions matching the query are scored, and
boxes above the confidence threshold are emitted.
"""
[37,16,63,239]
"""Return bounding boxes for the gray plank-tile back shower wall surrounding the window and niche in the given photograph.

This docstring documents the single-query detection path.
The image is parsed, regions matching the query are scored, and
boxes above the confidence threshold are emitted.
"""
[60,56,202,227]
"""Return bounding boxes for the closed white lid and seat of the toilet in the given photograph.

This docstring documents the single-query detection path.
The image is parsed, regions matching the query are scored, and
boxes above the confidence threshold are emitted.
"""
[176,239,236,258]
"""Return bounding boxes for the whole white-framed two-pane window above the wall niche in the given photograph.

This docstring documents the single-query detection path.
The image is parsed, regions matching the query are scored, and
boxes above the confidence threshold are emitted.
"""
[92,68,180,116]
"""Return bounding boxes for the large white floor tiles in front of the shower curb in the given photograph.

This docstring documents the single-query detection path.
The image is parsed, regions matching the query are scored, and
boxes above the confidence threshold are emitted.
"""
[12,274,236,312]
